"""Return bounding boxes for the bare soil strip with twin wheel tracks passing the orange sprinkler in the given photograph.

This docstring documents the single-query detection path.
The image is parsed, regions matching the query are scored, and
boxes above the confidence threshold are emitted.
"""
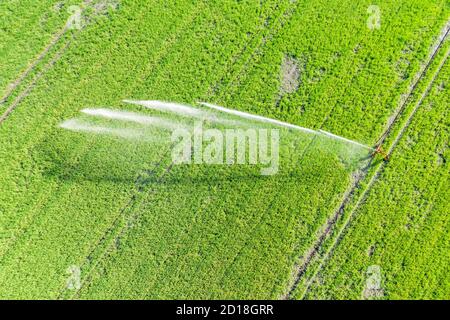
[281,21,450,299]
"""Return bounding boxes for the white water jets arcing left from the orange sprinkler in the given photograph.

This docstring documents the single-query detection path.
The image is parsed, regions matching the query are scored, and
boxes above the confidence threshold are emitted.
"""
[60,100,373,168]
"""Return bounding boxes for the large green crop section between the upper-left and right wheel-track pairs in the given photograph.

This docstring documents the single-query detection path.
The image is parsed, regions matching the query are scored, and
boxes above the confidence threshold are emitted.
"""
[0,0,450,298]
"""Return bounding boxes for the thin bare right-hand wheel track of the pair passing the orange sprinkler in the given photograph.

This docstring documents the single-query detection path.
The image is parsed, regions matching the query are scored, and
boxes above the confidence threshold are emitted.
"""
[298,43,450,299]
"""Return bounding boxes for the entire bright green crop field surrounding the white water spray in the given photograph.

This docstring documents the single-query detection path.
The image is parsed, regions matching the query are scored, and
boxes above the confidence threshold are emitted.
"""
[0,0,450,299]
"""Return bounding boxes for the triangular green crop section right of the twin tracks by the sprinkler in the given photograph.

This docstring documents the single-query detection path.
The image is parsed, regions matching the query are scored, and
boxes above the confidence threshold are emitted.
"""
[302,62,450,299]
